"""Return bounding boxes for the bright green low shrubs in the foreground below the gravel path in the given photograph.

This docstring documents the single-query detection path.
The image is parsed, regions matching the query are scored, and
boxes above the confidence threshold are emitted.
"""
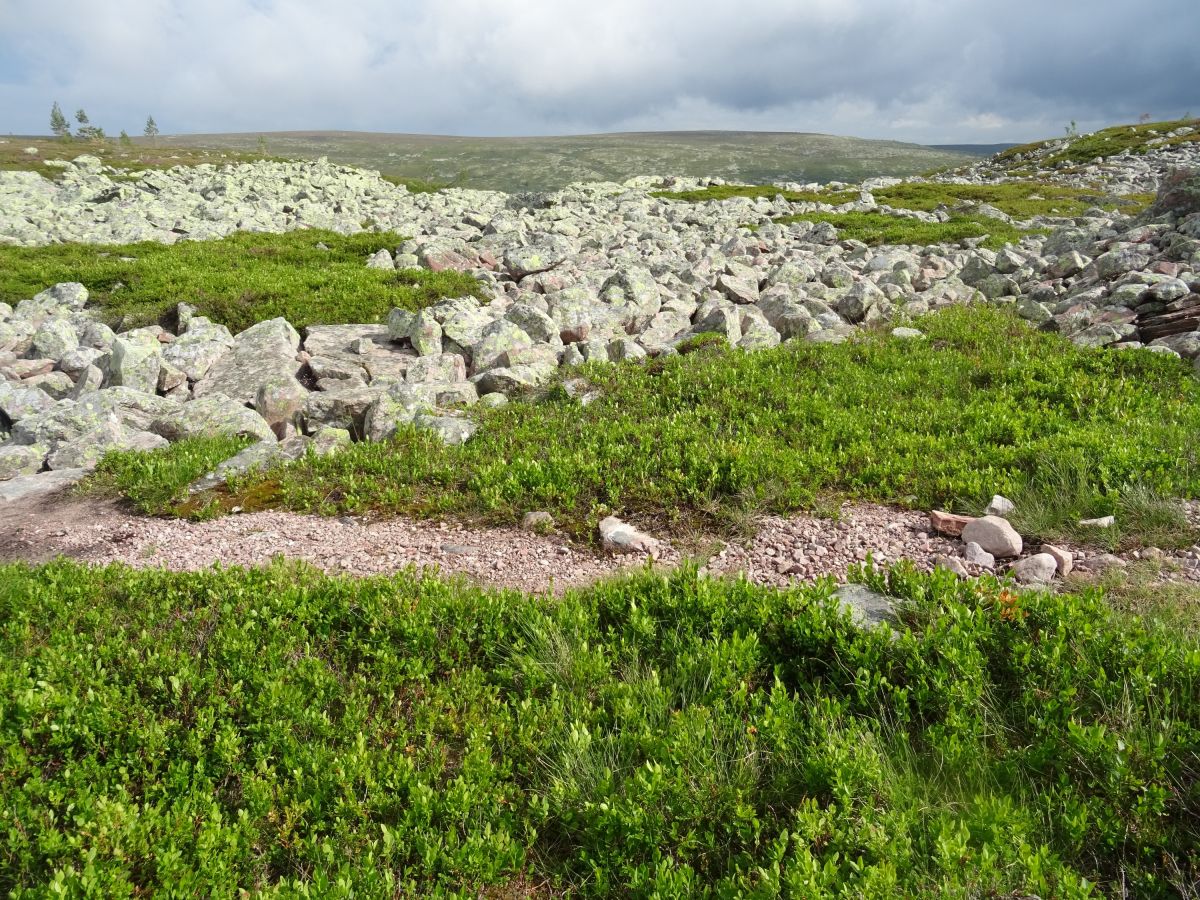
[0,562,1200,898]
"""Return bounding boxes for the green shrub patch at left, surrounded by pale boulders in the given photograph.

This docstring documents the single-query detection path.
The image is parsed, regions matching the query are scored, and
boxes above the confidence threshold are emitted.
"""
[0,229,480,334]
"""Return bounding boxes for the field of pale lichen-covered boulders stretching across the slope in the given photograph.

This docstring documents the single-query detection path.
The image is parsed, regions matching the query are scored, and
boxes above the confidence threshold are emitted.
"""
[0,131,1200,504]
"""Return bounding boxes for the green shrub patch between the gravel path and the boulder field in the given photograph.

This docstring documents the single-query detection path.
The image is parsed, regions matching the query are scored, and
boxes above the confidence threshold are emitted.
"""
[98,307,1200,542]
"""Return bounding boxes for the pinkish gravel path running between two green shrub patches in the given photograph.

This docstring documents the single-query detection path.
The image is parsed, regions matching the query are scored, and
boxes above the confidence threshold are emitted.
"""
[0,493,1200,593]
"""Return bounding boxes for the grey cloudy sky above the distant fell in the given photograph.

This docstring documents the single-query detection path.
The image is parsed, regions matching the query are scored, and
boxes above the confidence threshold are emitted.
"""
[0,0,1200,143]
